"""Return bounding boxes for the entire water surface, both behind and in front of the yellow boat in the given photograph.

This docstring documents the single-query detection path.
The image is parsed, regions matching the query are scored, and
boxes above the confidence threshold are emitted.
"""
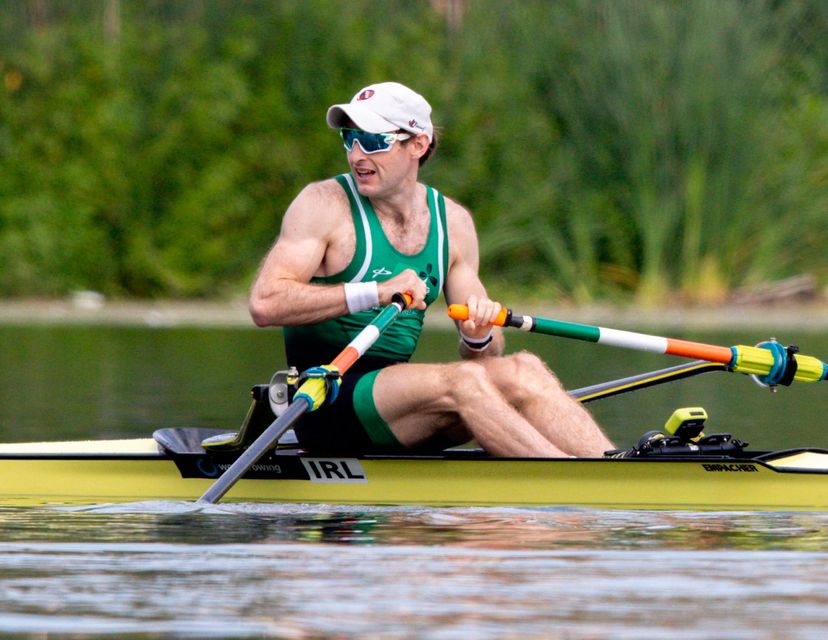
[0,326,828,640]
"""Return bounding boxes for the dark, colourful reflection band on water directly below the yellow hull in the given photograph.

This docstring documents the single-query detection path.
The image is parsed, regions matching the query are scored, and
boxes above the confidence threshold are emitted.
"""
[9,502,828,552]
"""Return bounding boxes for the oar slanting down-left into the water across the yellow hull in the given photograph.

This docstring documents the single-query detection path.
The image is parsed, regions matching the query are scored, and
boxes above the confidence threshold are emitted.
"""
[198,293,411,504]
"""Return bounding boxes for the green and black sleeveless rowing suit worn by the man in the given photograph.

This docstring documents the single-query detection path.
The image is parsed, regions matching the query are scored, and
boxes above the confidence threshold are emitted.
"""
[284,173,448,449]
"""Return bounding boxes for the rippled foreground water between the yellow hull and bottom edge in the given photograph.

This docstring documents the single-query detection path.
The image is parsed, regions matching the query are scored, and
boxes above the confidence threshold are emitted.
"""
[0,503,828,638]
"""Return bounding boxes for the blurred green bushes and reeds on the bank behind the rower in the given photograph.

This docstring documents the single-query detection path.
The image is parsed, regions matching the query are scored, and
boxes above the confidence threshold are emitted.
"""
[0,0,828,303]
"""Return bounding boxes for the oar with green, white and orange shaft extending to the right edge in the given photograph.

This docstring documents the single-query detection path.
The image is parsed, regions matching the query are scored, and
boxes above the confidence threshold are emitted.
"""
[448,304,828,387]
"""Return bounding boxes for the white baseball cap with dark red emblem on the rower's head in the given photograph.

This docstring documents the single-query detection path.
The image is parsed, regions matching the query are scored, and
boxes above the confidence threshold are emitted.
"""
[327,82,434,142]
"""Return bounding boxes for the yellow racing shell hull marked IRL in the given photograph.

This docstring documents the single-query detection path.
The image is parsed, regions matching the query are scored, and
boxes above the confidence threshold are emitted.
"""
[0,439,828,511]
